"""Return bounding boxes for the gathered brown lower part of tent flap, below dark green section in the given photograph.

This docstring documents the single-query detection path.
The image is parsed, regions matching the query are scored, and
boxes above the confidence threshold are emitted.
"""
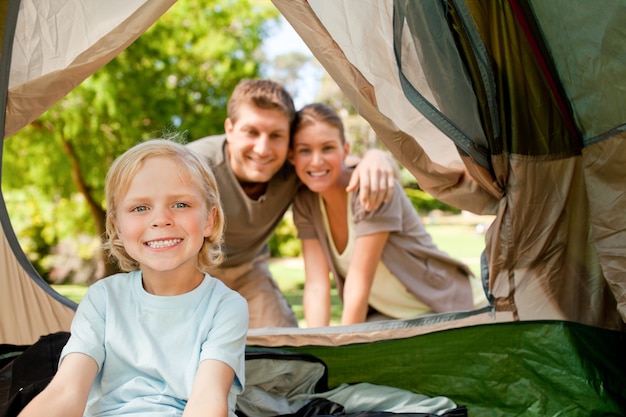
[486,155,623,329]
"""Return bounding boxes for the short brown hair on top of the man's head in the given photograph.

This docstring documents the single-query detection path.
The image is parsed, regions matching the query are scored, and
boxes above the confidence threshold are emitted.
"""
[227,79,296,124]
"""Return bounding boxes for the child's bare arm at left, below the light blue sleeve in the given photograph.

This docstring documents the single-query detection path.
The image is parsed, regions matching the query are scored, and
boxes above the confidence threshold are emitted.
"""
[19,353,98,417]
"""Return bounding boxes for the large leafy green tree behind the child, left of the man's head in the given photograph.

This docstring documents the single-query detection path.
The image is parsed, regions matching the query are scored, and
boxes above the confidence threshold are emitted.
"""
[3,0,278,282]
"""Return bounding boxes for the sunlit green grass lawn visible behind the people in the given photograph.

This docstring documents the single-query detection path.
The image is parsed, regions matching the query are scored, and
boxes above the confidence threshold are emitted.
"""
[52,219,489,327]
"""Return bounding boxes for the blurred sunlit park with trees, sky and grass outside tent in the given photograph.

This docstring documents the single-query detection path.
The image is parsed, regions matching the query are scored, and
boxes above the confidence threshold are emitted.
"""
[2,0,491,324]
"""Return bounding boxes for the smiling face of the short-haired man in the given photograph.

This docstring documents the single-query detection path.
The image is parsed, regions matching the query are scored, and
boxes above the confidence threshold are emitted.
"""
[224,103,290,183]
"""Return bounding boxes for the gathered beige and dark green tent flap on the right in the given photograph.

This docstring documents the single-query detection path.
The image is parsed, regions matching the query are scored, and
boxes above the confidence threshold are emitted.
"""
[273,0,626,329]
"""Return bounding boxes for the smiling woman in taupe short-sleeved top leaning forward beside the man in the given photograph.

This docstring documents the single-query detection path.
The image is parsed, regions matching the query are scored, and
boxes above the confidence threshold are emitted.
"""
[289,103,486,327]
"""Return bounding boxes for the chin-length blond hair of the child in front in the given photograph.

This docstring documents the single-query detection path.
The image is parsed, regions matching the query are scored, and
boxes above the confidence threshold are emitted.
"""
[104,139,224,272]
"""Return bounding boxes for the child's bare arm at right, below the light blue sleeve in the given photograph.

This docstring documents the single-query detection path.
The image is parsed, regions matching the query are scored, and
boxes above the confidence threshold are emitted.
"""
[183,359,235,417]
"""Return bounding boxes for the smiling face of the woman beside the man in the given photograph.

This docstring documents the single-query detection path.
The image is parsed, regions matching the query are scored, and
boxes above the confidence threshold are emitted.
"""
[289,121,348,193]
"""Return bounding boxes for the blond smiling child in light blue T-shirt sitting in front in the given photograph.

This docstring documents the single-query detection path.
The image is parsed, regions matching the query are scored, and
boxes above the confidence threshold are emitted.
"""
[20,140,248,417]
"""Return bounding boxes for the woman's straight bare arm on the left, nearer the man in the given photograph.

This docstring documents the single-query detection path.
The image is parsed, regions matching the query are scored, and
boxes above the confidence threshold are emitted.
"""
[302,239,330,328]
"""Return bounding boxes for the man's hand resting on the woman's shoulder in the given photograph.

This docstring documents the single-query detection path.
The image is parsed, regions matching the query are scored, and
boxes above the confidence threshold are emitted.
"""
[346,149,398,211]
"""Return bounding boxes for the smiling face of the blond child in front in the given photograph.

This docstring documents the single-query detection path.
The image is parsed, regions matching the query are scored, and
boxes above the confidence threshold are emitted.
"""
[116,157,214,276]
